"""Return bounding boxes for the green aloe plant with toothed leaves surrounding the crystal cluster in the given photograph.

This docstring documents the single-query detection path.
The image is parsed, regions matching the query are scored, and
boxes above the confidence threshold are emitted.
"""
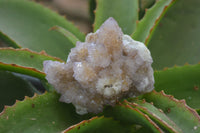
[0,0,200,133]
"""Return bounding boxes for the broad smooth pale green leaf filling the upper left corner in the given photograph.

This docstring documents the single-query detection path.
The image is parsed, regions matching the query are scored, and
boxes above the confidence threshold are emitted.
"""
[0,0,85,60]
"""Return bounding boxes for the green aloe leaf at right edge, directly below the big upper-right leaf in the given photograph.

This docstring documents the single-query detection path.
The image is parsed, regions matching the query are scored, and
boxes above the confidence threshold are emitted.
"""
[154,64,200,109]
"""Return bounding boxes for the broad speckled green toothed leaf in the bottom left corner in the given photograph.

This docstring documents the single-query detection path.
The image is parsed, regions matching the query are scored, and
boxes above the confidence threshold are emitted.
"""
[0,93,91,133]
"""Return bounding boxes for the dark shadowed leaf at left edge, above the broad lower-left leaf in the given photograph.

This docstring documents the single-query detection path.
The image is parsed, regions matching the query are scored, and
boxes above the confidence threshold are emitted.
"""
[0,71,35,112]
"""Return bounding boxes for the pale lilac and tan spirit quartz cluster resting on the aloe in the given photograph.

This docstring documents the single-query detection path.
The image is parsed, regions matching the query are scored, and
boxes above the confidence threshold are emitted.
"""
[44,18,154,114]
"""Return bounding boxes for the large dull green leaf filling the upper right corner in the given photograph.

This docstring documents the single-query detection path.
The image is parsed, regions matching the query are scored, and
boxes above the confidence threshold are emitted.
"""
[149,0,200,70]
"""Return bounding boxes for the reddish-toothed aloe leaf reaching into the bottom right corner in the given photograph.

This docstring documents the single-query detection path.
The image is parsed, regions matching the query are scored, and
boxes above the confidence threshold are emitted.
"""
[143,91,200,133]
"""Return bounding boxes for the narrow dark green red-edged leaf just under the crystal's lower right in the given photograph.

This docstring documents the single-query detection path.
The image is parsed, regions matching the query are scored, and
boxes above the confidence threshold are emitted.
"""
[103,103,163,133]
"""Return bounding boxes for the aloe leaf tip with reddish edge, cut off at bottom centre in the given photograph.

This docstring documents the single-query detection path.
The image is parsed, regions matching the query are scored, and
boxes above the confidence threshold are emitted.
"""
[63,116,133,133]
